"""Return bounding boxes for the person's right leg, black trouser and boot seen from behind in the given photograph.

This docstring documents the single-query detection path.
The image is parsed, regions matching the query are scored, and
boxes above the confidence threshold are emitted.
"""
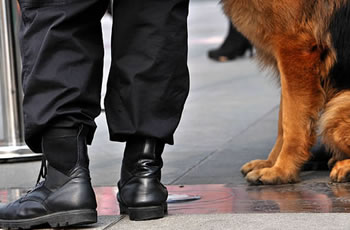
[105,0,189,220]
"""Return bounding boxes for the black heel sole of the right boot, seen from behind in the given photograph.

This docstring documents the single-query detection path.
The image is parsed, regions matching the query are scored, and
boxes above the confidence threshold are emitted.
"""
[119,203,168,221]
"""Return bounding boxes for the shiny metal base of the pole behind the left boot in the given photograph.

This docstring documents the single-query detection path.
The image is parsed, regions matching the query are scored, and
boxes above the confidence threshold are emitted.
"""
[0,145,42,163]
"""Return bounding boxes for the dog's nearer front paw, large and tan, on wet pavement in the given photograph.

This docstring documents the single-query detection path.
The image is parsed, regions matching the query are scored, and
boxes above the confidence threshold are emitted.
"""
[245,166,299,185]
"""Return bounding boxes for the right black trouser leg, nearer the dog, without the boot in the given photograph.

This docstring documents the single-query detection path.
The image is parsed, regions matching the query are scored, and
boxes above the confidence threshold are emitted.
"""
[105,0,189,144]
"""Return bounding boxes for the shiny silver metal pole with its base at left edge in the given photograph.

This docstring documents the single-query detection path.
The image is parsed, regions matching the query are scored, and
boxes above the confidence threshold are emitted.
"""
[0,0,40,162]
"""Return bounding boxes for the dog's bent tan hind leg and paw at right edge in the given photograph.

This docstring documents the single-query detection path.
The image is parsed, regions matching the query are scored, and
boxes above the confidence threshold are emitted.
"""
[320,91,350,182]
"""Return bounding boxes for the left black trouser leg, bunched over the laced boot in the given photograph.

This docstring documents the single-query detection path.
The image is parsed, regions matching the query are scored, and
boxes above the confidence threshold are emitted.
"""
[20,0,108,152]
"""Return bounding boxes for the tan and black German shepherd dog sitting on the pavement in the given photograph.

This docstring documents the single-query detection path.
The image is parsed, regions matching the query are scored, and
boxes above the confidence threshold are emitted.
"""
[222,0,350,184]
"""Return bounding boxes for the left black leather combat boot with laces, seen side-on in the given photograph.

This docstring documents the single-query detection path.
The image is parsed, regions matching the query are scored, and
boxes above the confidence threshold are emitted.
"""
[0,127,97,229]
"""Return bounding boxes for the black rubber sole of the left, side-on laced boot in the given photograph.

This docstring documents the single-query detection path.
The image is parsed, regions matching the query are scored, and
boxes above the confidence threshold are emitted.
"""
[0,210,97,229]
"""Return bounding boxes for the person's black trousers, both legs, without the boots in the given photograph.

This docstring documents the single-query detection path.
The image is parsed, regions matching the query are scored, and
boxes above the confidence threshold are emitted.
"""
[19,0,189,152]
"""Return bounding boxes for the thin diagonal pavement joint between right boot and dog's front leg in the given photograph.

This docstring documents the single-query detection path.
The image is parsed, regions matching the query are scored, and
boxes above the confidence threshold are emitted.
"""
[169,105,279,185]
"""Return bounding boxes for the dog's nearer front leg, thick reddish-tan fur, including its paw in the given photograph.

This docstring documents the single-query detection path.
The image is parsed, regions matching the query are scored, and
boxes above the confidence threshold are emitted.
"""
[246,35,324,184]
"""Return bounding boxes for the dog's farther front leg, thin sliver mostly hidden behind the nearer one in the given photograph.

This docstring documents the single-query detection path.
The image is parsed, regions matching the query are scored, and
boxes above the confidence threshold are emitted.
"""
[241,95,283,176]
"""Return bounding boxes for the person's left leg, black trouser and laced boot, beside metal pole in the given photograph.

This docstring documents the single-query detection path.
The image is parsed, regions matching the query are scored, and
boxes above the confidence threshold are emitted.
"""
[0,0,107,228]
